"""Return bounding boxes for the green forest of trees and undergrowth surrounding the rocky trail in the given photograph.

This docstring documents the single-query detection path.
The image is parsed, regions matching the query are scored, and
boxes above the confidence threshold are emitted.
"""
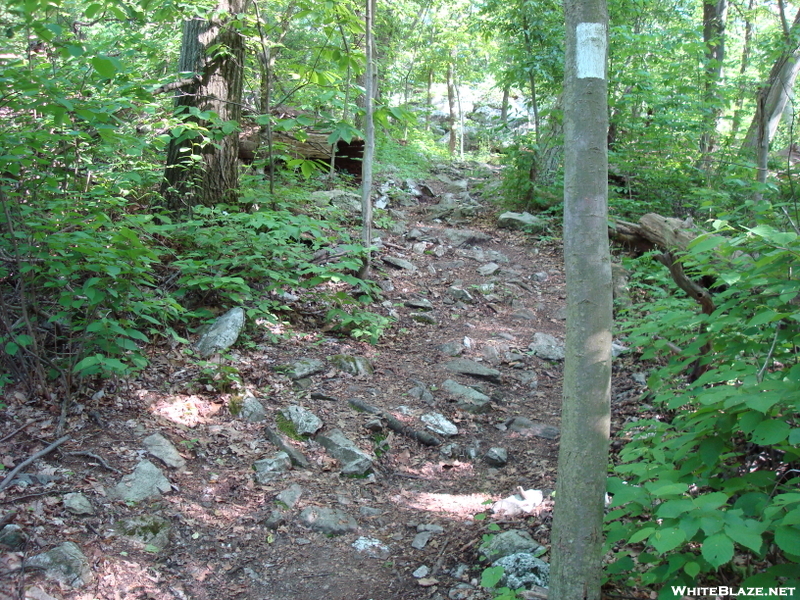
[0,0,800,595]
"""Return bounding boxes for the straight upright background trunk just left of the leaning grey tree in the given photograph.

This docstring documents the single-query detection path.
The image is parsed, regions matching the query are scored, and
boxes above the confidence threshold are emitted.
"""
[700,0,728,170]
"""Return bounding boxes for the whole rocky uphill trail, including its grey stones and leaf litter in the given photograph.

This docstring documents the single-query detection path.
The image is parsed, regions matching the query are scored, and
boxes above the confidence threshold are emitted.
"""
[0,165,642,600]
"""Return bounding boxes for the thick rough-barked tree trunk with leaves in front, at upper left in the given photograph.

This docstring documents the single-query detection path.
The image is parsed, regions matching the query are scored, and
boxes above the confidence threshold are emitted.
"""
[161,0,245,211]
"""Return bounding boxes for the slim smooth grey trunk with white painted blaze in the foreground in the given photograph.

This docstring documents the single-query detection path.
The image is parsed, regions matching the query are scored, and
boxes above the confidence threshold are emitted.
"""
[550,0,612,600]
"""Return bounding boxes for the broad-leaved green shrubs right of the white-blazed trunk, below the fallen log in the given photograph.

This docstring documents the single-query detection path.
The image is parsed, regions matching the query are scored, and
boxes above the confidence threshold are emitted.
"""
[607,221,800,597]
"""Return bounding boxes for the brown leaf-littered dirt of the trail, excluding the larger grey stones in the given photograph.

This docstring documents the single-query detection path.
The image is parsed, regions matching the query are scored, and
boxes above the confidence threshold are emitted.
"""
[0,163,641,600]
